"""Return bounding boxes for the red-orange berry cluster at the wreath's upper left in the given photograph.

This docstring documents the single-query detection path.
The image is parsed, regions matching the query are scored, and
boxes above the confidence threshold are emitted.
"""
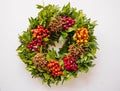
[31,25,50,39]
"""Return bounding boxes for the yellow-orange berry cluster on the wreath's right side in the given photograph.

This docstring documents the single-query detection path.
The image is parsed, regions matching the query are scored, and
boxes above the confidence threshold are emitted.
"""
[73,27,89,44]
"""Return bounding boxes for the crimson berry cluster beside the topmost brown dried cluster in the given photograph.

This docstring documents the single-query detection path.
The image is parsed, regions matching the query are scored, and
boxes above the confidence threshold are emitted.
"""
[62,17,75,30]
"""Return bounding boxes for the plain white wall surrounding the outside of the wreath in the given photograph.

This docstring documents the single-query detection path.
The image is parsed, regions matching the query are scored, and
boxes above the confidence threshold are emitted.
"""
[0,0,120,91]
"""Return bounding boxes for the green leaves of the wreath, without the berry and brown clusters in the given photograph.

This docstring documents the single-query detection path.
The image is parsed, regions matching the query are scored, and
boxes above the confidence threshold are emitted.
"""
[17,3,98,86]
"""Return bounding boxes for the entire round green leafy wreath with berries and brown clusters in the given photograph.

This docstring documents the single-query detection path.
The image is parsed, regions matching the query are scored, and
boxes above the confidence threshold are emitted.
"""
[17,3,98,86]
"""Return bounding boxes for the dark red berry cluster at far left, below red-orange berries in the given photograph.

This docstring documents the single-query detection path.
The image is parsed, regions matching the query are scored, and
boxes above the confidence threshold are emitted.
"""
[27,39,44,51]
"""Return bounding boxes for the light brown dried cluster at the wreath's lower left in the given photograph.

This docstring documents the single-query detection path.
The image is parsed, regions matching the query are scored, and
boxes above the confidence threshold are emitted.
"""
[33,53,48,70]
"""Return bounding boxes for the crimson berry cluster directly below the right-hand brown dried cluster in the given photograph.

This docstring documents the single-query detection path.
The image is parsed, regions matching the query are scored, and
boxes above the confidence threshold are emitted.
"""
[63,55,77,71]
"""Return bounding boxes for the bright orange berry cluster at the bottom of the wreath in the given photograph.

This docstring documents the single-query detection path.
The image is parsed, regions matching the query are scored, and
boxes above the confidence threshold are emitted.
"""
[47,60,63,77]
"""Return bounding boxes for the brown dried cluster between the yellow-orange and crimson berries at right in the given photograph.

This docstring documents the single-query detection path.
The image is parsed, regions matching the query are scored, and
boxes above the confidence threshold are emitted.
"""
[68,44,84,59]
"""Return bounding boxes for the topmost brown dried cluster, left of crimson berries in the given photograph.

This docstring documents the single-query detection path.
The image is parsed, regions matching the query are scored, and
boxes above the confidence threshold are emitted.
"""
[49,16,62,33]
